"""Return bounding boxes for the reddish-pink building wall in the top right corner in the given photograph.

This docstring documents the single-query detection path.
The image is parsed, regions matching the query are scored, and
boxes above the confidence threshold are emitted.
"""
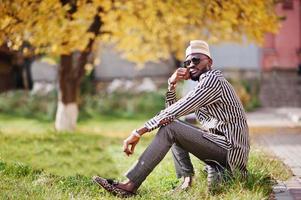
[262,0,301,71]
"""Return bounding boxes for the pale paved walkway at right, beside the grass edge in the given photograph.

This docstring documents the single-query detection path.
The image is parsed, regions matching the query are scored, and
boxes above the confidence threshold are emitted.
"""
[248,108,301,200]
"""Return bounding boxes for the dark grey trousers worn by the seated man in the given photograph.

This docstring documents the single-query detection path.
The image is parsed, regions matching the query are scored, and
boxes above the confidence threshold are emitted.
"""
[126,120,227,187]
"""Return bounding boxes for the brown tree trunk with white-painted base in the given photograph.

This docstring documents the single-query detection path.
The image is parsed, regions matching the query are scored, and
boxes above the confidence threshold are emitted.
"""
[55,5,102,131]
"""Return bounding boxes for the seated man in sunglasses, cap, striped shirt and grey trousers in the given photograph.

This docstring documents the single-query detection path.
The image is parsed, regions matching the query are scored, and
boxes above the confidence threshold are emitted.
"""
[93,40,250,197]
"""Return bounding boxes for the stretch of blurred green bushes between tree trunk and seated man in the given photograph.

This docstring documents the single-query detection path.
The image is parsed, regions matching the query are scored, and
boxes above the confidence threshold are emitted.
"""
[80,91,165,119]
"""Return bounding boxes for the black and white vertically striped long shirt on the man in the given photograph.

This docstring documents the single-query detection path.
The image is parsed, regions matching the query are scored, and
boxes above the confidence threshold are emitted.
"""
[145,70,250,175]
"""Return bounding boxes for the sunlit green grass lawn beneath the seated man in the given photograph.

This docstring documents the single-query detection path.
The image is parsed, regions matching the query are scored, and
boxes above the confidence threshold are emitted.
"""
[0,114,291,200]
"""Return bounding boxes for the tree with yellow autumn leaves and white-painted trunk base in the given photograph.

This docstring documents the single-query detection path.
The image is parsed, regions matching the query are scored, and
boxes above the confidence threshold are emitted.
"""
[0,0,278,130]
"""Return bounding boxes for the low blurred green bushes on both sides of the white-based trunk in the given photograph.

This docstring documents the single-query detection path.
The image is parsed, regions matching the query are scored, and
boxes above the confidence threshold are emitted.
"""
[0,90,165,121]
